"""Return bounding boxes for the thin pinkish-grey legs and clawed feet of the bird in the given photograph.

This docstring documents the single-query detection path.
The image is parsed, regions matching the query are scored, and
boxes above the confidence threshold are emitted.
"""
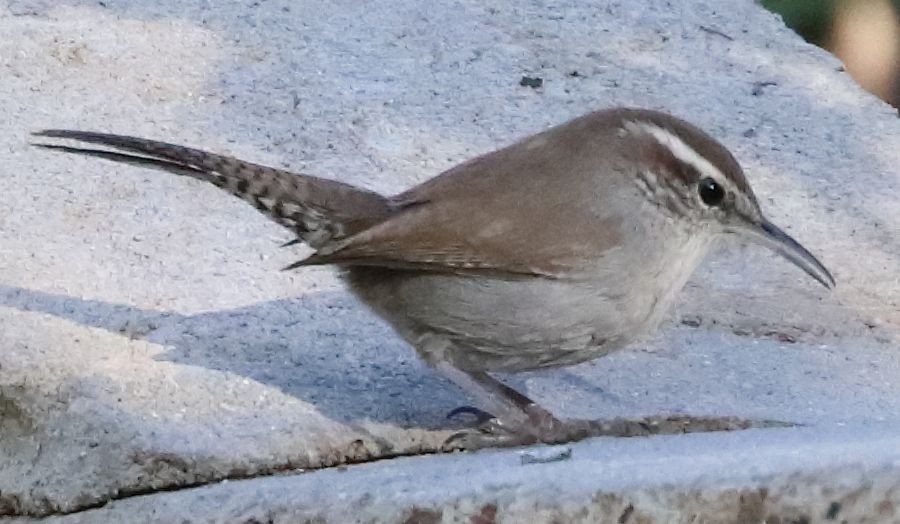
[435,362,562,444]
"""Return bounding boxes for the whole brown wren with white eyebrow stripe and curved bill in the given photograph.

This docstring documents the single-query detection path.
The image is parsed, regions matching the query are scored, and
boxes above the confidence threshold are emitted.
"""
[36,109,834,440]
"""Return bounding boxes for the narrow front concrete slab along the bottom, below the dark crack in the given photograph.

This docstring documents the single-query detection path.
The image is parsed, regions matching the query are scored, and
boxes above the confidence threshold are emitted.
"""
[26,426,900,524]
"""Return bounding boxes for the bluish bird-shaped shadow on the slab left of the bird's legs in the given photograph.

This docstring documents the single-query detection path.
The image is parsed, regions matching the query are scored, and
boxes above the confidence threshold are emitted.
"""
[0,285,465,429]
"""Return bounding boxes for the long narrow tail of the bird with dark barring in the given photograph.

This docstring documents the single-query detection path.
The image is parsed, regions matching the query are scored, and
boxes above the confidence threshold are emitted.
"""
[33,129,390,249]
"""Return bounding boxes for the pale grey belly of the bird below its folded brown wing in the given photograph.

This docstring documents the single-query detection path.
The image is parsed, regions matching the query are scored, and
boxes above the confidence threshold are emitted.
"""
[347,268,660,371]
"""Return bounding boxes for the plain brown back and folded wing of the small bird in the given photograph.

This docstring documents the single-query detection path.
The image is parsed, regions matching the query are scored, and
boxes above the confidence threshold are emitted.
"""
[298,113,620,277]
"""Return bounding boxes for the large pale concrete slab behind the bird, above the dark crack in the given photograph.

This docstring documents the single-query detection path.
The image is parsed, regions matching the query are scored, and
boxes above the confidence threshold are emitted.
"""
[0,0,900,518]
